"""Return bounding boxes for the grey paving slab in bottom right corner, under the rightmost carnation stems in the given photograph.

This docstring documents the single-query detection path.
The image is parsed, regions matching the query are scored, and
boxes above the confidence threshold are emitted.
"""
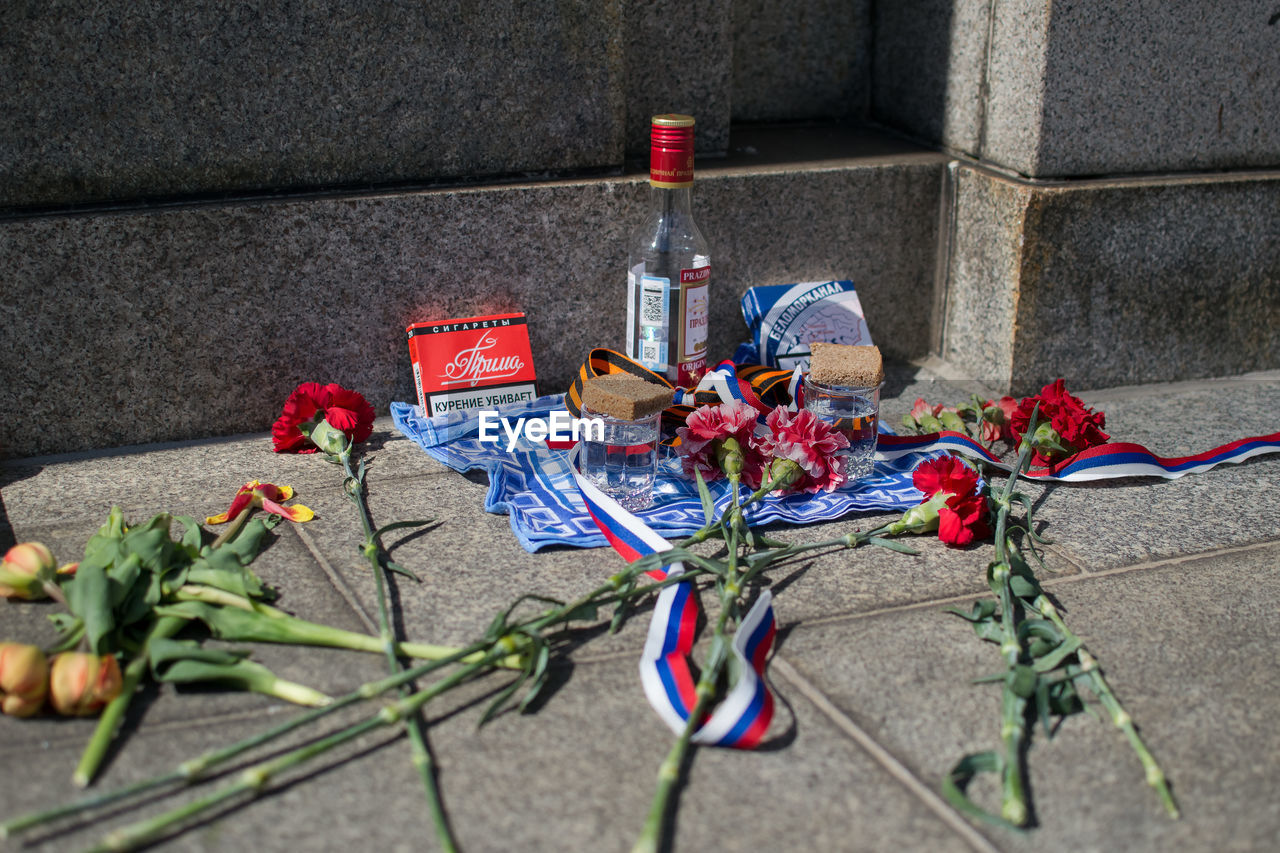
[778,544,1280,850]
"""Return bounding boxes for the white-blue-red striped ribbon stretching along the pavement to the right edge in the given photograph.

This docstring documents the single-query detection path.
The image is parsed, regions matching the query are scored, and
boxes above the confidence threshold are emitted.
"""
[876,430,1280,483]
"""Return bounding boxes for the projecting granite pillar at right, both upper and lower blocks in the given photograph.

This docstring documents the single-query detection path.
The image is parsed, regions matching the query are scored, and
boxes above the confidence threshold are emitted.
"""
[872,0,1280,392]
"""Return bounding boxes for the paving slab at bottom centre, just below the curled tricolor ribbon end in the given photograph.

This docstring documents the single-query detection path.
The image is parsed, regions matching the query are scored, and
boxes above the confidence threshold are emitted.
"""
[0,648,968,850]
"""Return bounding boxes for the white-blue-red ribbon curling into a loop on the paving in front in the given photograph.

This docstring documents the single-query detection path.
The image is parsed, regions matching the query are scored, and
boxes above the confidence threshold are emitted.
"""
[570,362,776,749]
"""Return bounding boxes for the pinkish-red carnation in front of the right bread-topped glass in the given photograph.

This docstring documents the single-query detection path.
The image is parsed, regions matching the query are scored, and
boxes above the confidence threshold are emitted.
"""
[756,406,849,494]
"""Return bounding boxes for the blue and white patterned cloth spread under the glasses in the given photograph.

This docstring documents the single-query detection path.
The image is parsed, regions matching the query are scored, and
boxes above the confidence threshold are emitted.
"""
[392,394,941,552]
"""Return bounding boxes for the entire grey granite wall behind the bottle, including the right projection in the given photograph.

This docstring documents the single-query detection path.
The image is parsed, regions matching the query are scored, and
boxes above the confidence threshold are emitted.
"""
[0,0,1280,456]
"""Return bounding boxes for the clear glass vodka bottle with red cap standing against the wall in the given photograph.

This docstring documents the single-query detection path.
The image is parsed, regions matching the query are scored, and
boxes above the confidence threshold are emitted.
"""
[627,114,712,388]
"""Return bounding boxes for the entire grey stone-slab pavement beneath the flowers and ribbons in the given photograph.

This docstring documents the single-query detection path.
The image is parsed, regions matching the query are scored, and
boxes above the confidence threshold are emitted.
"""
[0,368,1280,852]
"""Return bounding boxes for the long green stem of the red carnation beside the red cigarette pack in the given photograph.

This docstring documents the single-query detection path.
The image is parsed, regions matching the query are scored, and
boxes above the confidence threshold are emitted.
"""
[340,444,457,853]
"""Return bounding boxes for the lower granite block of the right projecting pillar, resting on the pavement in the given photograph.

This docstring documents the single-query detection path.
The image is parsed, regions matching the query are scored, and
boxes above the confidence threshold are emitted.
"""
[941,167,1280,393]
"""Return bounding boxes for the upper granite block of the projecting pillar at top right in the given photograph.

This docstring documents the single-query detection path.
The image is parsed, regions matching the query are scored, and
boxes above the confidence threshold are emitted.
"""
[872,0,1280,178]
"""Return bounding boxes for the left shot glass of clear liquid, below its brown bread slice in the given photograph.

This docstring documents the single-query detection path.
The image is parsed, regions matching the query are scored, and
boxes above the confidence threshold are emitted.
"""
[580,406,662,511]
